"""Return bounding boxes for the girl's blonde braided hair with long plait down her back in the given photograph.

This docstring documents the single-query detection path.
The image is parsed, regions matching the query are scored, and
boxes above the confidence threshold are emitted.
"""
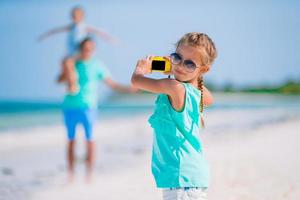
[176,32,217,127]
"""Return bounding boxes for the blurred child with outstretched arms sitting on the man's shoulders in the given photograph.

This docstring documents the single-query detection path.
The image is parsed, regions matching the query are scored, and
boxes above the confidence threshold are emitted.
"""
[38,6,116,93]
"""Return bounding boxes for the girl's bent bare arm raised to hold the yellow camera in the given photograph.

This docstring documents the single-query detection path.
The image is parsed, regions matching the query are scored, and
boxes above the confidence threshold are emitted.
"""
[131,56,185,110]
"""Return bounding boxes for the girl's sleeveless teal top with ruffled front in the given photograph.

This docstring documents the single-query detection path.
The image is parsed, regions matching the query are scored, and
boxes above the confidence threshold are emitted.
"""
[149,83,209,188]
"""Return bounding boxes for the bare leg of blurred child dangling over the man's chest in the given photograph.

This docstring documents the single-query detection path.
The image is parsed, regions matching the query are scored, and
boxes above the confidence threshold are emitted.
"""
[58,57,78,93]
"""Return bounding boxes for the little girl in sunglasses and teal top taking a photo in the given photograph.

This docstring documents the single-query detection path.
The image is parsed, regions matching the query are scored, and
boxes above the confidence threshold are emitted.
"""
[131,32,217,200]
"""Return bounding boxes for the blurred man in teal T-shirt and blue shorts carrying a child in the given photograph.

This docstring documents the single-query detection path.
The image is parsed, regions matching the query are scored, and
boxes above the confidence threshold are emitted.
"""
[61,38,137,180]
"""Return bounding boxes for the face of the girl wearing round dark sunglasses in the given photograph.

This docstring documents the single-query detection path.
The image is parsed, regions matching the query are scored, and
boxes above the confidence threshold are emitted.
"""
[172,45,204,82]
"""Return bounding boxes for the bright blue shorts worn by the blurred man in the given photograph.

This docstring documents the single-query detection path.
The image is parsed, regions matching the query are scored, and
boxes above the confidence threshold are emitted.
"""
[63,109,97,141]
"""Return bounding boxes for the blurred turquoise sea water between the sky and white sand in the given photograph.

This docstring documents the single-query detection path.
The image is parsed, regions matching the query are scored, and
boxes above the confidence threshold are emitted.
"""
[0,93,300,133]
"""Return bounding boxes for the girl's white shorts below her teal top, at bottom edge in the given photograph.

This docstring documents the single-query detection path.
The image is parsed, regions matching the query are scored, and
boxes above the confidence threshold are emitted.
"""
[163,188,207,200]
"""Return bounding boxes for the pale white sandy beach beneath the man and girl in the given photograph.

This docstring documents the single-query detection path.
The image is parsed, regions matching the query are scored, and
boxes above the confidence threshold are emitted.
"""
[0,110,300,200]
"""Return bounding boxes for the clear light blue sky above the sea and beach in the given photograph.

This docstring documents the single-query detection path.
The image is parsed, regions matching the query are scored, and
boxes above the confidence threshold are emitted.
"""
[0,0,300,101]
